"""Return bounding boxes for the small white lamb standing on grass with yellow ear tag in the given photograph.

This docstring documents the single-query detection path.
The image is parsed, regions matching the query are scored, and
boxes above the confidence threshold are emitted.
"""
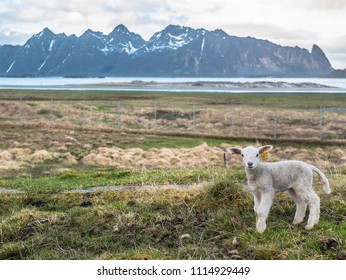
[227,145,331,233]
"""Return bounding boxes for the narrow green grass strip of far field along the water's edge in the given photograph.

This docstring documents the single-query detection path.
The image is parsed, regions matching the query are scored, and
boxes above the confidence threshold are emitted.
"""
[0,89,346,111]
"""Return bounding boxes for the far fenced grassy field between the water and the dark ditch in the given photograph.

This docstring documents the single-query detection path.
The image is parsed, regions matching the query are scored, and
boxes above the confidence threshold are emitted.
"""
[0,90,346,140]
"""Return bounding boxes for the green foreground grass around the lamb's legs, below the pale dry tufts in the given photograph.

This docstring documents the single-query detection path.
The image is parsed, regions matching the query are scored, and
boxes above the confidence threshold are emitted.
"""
[0,166,346,259]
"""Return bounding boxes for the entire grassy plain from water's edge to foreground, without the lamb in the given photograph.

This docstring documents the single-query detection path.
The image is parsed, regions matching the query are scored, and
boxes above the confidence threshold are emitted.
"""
[0,89,346,259]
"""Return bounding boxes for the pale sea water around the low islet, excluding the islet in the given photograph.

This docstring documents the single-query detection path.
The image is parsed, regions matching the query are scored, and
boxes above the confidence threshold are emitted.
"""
[0,77,346,92]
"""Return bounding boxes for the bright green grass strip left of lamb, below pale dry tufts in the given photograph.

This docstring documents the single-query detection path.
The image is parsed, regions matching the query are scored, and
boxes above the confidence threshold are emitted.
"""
[0,167,222,193]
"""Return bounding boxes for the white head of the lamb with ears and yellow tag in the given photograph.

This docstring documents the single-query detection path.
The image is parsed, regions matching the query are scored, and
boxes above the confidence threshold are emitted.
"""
[227,145,273,169]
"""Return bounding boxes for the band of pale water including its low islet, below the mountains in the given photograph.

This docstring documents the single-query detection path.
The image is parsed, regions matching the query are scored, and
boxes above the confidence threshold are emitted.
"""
[0,77,346,93]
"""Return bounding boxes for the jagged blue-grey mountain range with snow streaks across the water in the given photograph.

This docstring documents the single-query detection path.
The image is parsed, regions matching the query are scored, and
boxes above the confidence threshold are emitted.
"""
[0,24,334,77]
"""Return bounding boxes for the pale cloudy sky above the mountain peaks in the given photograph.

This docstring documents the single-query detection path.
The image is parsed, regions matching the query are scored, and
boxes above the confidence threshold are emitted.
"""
[0,0,346,69]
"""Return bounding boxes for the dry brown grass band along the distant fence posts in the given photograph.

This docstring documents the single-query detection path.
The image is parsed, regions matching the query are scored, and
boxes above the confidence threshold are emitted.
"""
[0,100,346,139]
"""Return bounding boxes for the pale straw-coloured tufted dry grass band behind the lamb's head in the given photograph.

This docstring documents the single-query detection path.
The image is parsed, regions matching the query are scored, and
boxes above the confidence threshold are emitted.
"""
[0,137,346,173]
